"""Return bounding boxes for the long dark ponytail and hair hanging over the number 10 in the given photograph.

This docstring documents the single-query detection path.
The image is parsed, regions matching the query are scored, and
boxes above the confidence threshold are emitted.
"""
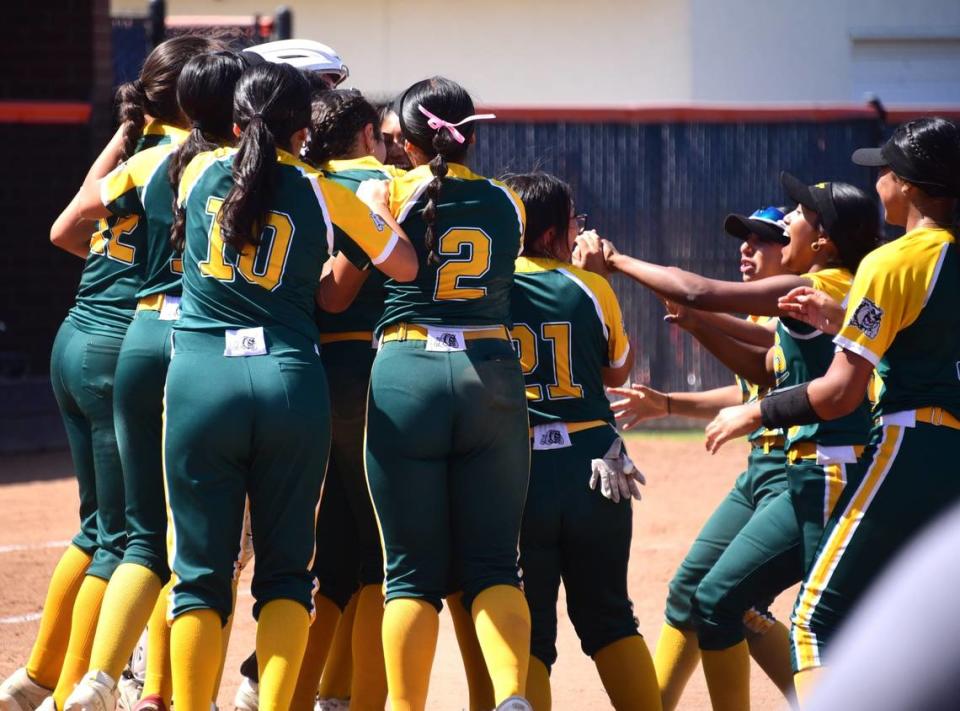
[219,63,310,252]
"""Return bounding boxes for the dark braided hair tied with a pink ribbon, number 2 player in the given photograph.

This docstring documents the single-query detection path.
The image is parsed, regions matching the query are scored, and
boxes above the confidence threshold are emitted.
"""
[398,77,474,263]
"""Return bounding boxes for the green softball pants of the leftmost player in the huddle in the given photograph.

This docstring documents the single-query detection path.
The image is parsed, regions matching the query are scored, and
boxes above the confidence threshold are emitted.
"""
[50,319,126,580]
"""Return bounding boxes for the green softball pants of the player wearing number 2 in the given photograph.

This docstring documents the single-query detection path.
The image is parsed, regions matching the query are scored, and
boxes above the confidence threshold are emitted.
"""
[366,339,530,610]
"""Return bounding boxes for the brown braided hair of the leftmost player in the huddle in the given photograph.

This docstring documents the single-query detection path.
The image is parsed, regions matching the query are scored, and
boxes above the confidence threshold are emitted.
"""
[117,35,225,160]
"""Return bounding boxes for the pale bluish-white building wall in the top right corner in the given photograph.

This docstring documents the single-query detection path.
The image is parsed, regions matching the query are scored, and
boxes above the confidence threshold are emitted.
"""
[691,0,960,104]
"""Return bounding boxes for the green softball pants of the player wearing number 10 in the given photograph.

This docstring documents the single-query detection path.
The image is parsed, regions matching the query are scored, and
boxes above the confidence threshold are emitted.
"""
[164,329,330,621]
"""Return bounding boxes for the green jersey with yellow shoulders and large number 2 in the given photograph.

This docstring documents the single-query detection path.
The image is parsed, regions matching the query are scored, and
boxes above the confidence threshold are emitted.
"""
[377,163,526,330]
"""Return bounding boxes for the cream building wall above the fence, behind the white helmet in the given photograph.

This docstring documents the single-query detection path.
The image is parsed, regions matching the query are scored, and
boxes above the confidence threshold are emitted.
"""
[112,0,690,106]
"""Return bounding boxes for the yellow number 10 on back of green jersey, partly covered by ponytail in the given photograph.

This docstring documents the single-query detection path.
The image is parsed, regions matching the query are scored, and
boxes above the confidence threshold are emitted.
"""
[199,197,293,291]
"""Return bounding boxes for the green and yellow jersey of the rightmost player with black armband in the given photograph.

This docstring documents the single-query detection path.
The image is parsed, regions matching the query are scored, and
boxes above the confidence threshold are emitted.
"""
[836,227,960,417]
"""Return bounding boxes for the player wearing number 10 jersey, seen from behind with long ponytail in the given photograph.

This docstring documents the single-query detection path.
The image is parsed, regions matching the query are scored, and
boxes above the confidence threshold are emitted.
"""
[164,64,416,711]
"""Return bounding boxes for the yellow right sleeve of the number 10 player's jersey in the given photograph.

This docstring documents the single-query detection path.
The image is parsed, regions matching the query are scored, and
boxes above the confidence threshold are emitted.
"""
[311,176,400,269]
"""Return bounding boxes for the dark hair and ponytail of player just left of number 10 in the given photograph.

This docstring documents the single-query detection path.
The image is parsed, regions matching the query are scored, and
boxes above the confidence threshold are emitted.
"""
[167,52,246,252]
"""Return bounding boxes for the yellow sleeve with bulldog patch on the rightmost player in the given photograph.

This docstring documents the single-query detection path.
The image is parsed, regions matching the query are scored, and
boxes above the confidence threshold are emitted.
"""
[834,237,948,365]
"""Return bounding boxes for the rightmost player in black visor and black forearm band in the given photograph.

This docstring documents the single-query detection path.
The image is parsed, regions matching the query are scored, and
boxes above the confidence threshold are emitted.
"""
[708,118,960,701]
